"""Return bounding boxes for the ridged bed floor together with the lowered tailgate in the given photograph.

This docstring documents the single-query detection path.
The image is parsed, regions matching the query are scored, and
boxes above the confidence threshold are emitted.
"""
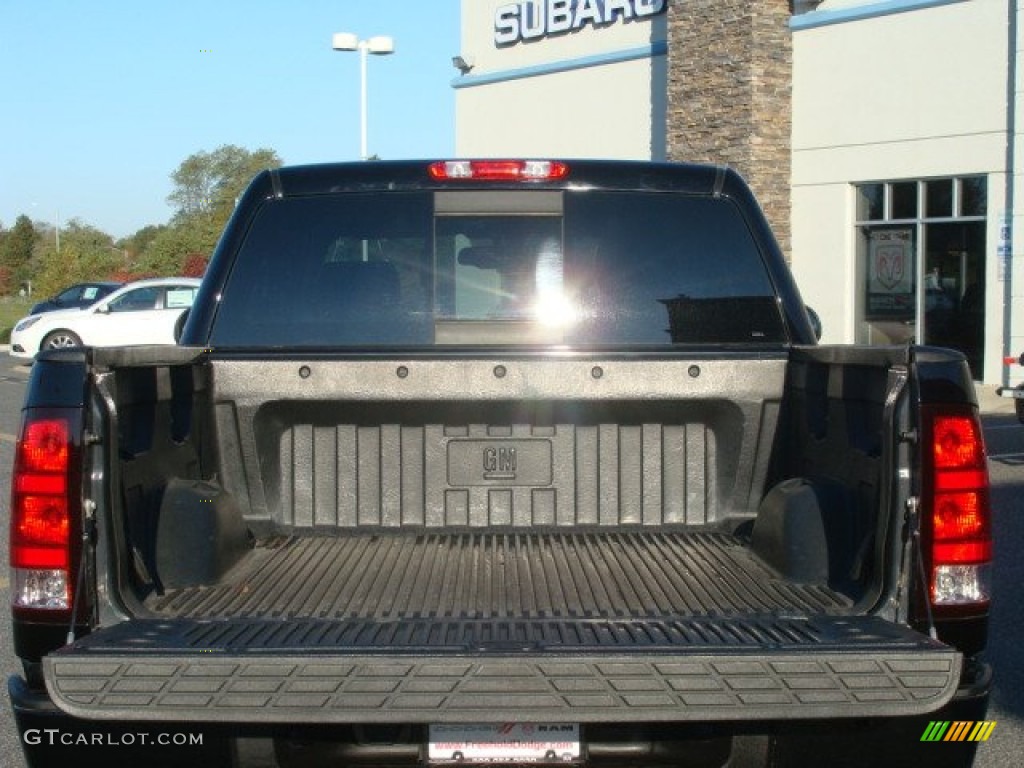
[45,529,959,724]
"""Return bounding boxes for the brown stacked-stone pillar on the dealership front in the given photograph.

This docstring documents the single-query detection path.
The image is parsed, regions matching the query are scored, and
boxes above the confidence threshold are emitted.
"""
[667,0,793,259]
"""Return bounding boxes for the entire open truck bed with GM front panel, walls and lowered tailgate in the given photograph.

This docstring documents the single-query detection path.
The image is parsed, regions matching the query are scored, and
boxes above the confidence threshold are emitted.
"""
[43,350,962,725]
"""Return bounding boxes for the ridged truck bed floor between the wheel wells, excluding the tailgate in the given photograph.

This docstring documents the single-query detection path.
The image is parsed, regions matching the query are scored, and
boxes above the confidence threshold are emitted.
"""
[147,531,849,621]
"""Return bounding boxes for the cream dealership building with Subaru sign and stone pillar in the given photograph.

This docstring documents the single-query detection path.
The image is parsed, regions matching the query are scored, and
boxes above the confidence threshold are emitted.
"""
[453,0,1024,384]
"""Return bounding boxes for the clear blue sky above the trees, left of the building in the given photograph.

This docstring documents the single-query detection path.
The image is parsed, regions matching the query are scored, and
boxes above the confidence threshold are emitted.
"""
[0,0,459,237]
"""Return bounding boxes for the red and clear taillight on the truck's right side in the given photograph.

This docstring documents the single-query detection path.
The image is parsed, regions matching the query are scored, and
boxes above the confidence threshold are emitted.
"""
[922,407,992,605]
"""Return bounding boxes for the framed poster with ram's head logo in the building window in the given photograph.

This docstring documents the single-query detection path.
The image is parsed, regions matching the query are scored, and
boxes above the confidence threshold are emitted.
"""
[865,229,913,319]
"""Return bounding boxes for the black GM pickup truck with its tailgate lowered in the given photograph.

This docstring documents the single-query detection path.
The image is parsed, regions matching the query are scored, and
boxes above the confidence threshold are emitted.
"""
[8,161,992,768]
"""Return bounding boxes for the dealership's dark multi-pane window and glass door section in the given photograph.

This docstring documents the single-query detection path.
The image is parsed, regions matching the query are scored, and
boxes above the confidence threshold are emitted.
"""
[855,176,988,378]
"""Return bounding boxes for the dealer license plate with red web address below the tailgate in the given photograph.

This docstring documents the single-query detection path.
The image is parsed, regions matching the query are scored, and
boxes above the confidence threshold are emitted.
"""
[427,723,582,765]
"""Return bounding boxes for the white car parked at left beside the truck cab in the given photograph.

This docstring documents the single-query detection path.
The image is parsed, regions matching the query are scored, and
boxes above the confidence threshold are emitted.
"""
[10,278,200,358]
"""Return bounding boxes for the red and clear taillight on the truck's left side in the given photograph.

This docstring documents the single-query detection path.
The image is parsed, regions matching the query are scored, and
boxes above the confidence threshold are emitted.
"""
[10,415,73,610]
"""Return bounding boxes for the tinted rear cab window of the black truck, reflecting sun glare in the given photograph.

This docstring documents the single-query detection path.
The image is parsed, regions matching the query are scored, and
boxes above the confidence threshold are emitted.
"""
[210,189,786,347]
